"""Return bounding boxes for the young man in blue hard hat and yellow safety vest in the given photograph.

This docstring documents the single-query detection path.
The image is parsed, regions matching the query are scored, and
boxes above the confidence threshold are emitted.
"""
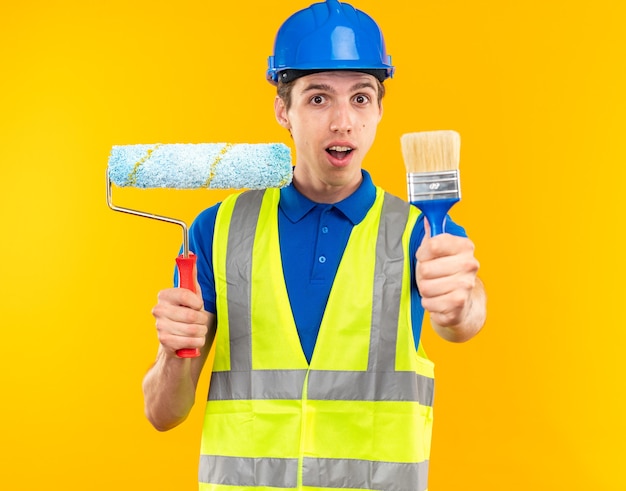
[144,1,485,491]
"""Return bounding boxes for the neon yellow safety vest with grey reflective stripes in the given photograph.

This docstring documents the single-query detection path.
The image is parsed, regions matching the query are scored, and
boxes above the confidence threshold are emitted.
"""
[199,188,434,491]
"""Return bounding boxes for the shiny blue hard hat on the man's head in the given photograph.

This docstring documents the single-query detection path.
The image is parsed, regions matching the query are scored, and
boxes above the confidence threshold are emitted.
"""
[267,0,394,85]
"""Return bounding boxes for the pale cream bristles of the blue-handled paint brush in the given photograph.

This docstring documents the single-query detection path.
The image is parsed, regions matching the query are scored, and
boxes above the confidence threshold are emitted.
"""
[400,130,461,174]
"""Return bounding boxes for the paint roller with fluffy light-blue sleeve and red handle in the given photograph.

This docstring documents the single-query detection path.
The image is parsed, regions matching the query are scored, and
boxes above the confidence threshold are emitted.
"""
[106,143,293,358]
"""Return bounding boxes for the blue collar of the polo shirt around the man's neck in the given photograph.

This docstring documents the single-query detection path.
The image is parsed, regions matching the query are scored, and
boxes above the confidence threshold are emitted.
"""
[279,169,376,225]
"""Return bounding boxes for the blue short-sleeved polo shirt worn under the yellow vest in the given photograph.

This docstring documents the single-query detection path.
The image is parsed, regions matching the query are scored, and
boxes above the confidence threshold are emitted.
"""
[184,171,465,362]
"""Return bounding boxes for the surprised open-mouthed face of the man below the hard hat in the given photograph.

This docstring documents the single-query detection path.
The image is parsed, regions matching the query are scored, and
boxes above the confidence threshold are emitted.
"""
[275,71,382,196]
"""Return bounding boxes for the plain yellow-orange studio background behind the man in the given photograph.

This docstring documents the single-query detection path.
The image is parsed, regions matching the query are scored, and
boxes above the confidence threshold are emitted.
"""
[0,0,626,491]
